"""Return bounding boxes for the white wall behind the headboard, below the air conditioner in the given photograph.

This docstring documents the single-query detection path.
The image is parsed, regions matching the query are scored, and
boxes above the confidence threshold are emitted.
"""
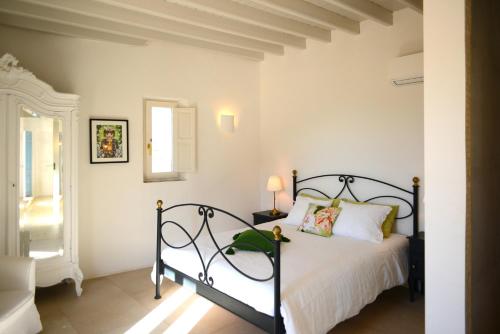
[260,10,425,233]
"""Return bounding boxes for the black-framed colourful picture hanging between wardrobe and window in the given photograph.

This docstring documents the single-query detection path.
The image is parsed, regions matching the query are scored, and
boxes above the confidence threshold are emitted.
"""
[90,118,128,164]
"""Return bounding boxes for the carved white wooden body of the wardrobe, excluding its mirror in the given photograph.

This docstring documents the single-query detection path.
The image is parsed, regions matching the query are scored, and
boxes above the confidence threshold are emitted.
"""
[0,54,83,295]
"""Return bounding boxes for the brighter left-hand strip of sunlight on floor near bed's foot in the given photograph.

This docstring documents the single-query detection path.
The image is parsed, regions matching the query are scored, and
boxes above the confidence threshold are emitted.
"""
[125,288,193,334]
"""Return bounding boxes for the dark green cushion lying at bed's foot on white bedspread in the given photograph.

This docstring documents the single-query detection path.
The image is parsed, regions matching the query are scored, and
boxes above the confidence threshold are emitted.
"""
[226,229,290,256]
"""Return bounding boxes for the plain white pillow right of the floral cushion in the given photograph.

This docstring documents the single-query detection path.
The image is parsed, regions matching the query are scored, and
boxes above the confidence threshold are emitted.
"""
[332,201,391,243]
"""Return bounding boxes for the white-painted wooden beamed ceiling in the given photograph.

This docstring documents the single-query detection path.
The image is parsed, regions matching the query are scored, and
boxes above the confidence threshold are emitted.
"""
[0,0,423,61]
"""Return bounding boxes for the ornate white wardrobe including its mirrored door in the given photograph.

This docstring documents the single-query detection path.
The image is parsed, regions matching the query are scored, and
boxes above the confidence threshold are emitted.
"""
[0,54,83,295]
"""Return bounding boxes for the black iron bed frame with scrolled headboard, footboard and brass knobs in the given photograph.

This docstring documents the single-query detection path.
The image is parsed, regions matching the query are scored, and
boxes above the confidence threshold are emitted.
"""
[155,170,419,334]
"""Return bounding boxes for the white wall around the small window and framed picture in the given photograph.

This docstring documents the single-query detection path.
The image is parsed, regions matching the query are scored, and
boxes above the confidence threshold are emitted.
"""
[0,27,259,278]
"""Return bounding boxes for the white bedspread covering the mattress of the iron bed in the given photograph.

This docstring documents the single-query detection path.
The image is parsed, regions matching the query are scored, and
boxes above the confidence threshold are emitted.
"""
[158,220,408,334]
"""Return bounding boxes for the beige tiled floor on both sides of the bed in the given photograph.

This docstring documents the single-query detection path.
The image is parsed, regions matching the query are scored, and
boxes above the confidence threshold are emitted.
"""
[36,269,424,334]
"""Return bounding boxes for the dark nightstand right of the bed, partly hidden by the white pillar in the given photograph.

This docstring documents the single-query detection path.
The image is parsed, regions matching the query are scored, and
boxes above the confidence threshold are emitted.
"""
[408,232,425,301]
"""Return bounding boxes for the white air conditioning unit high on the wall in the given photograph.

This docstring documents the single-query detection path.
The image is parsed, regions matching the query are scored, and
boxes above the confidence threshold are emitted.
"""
[389,52,424,86]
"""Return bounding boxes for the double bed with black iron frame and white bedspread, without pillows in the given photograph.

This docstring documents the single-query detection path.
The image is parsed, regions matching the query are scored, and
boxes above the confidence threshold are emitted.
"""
[154,171,419,333]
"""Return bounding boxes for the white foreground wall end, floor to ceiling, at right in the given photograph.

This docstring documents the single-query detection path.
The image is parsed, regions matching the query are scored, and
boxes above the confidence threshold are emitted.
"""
[424,0,466,334]
